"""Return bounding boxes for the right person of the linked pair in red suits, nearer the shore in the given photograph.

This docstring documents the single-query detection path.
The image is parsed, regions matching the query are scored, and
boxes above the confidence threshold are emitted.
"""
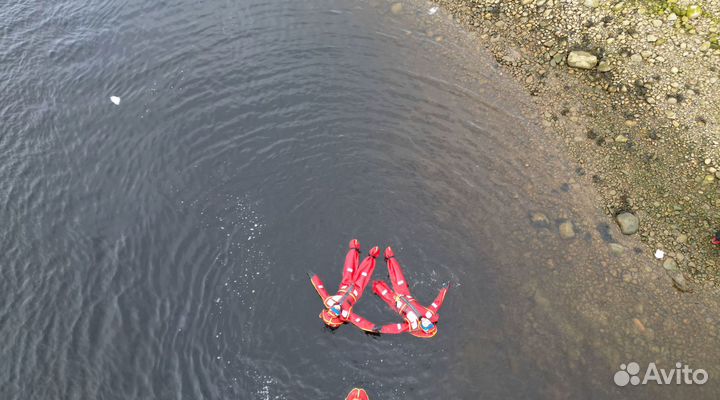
[373,247,450,338]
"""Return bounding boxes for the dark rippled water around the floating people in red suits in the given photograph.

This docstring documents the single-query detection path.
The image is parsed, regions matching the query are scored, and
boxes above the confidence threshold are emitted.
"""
[0,0,710,399]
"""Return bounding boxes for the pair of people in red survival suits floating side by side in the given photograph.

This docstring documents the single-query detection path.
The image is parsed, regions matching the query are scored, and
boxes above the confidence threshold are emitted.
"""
[308,239,449,338]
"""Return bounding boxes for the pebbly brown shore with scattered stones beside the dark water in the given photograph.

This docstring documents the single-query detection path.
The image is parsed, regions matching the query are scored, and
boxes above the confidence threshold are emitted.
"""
[434,0,720,291]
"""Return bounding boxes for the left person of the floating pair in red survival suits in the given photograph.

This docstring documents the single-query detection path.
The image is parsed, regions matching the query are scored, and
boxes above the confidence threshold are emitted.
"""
[308,239,380,333]
